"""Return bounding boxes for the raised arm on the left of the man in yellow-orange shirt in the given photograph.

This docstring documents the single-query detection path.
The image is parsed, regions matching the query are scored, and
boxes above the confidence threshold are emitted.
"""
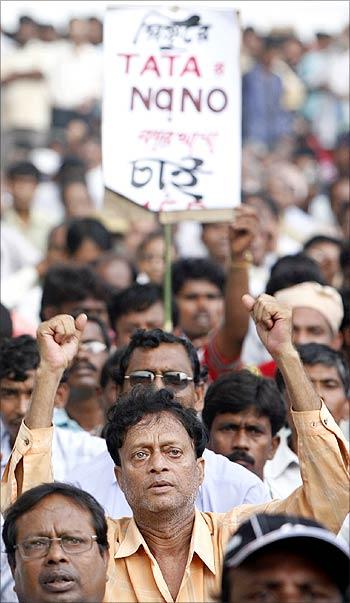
[1,314,87,511]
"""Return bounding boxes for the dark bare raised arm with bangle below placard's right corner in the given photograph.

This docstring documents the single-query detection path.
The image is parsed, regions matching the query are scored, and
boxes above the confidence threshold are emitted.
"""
[215,205,258,359]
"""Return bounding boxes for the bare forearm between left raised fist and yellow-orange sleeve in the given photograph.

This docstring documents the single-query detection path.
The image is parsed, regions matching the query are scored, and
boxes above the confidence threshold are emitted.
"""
[24,364,63,429]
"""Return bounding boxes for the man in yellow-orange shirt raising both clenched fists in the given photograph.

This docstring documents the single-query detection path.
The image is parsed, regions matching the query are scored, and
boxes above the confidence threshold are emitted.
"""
[2,295,349,603]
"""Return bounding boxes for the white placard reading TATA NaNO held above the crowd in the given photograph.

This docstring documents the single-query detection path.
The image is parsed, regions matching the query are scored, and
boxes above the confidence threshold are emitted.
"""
[102,5,241,212]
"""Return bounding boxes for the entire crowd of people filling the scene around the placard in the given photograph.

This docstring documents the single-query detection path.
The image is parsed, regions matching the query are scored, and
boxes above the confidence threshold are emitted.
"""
[0,11,350,603]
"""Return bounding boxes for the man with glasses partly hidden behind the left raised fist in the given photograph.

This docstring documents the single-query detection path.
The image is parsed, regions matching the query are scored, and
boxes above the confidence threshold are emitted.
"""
[54,315,111,435]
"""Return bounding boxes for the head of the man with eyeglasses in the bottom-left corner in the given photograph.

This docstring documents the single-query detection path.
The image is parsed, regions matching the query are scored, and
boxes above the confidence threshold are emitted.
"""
[1,482,109,603]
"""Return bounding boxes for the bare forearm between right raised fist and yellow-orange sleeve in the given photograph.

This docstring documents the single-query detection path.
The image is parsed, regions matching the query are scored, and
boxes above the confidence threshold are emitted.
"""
[275,347,321,411]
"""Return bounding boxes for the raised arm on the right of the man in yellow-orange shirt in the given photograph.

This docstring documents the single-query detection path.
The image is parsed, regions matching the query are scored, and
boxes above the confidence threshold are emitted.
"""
[239,295,349,533]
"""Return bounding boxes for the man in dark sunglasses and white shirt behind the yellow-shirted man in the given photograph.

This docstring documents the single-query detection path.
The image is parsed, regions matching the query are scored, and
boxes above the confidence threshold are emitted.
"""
[66,329,270,517]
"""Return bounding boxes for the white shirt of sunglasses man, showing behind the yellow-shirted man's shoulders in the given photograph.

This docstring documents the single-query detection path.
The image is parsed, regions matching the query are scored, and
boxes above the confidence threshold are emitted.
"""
[65,449,270,519]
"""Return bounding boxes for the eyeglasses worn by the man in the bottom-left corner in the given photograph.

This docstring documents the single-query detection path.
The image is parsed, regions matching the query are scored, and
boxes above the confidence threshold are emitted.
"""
[14,535,97,559]
